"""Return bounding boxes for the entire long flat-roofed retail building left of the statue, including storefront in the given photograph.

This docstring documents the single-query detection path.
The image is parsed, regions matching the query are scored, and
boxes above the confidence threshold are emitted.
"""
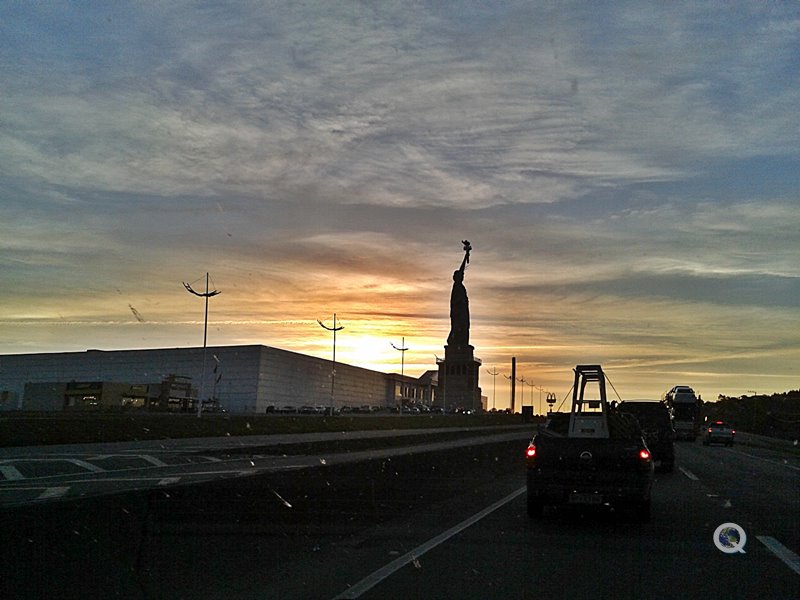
[0,345,437,414]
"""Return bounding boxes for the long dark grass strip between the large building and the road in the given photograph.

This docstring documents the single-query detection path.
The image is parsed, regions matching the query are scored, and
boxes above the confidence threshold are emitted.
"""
[0,412,524,447]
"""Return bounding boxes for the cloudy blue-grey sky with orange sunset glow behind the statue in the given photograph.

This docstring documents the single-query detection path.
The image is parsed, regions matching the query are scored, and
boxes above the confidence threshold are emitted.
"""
[0,0,800,407]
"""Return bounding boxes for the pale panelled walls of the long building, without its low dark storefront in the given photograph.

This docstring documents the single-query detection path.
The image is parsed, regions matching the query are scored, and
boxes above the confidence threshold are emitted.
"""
[0,345,415,414]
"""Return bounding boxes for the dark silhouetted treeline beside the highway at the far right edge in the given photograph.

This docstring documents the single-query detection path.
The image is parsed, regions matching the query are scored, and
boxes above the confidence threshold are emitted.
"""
[703,390,800,440]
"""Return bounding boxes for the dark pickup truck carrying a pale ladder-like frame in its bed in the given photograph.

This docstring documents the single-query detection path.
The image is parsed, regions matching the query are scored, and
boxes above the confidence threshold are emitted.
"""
[525,365,654,522]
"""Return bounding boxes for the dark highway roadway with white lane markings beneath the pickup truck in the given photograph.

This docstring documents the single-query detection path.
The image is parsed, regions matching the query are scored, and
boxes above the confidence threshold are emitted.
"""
[0,432,800,600]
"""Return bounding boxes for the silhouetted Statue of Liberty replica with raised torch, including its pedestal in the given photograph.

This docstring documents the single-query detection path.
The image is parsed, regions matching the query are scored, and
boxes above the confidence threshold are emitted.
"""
[436,240,483,412]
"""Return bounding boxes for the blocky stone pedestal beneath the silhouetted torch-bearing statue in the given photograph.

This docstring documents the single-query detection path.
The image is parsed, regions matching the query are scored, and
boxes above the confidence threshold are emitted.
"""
[438,345,483,412]
